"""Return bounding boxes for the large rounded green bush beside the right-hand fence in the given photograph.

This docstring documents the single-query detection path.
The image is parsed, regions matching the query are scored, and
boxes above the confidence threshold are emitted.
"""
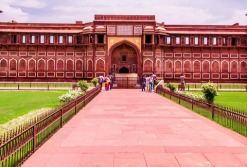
[202,82,217,103]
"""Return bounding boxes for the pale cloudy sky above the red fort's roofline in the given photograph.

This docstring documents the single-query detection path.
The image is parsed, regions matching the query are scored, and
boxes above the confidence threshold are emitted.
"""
[0,0,247,25]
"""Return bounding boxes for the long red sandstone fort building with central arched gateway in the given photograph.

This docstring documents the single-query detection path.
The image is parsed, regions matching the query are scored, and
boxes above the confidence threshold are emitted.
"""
[0,15,247,82]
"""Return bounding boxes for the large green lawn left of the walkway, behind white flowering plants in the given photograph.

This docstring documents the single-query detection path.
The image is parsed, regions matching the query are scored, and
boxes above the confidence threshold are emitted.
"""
[0,91,67,124]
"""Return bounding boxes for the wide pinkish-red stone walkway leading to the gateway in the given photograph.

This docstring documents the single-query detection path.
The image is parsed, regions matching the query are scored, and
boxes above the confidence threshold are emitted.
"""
[23,89,247,167]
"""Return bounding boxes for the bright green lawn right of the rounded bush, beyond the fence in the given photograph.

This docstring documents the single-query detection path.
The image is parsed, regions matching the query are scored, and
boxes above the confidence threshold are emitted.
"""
[214,92,247,113]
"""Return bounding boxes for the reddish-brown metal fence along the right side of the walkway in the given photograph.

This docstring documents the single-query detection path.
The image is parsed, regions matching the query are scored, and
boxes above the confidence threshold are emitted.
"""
[156,85,247,136]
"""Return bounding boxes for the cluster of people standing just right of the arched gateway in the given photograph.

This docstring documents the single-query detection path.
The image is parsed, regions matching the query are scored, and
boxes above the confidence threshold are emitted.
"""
[141,73,156,93]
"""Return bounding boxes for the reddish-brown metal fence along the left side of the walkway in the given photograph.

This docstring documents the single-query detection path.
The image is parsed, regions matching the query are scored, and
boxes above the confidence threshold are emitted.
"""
[0,86,100,167]
